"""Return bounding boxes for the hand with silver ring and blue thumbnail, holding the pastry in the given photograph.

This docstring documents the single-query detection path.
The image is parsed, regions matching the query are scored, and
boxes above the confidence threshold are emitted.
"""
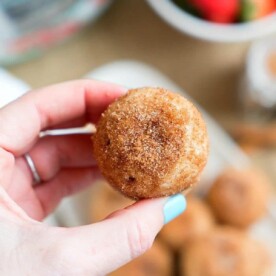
[0,80,185,275]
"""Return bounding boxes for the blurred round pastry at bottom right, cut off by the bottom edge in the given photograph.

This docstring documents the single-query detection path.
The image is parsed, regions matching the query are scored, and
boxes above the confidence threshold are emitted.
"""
[180,227,271,276]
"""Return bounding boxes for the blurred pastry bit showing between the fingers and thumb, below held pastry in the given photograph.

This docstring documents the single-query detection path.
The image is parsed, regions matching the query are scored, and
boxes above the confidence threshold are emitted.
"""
[90,181,134,222]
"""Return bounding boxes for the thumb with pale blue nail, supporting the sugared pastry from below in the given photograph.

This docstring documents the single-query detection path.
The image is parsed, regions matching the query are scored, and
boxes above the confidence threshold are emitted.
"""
[50,194,186,275]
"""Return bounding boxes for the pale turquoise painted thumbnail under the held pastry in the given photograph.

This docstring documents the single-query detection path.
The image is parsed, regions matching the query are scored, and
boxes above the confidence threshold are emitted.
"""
[163,194,186,224]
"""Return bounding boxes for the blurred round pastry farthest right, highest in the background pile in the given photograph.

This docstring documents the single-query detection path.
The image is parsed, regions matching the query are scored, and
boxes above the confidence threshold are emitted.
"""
[207,169,269,227]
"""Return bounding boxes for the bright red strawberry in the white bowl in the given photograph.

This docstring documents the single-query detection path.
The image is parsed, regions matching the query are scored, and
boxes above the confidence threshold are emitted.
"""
[188,0,240,23]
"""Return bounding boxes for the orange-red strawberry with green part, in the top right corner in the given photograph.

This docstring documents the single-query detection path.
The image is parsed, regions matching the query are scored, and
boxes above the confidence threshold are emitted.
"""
[241,0,276,21]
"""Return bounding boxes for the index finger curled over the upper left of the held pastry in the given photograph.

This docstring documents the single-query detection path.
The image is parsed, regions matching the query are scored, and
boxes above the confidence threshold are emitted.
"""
[0,80,126,156]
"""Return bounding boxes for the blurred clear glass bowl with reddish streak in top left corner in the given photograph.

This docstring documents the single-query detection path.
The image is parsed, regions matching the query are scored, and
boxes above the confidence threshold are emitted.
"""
[0,0,113,66]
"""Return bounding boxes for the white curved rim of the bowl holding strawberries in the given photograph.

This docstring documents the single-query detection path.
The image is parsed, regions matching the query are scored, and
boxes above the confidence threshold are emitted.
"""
[147,0,276,42]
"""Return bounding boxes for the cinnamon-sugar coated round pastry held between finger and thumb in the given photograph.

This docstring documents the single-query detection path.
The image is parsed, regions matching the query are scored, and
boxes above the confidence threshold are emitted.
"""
[92,88,208,199]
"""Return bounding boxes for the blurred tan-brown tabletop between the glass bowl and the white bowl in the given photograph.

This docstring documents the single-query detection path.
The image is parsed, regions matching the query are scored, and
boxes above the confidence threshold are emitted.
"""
[5,0,276,179]
